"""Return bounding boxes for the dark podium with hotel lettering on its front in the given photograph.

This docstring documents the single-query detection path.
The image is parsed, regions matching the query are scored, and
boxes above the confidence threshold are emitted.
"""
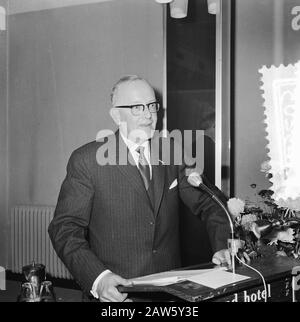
[119,257,300,302]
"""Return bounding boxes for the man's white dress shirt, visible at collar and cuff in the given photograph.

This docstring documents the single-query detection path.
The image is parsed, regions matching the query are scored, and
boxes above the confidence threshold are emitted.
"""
[90,131,152,299]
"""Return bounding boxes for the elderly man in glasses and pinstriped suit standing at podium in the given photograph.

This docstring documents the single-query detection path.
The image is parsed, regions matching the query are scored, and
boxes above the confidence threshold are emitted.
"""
[49,76,230,301]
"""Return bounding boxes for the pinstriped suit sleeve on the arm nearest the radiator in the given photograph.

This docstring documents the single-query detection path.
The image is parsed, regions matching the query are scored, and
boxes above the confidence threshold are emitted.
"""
[48,151,106,292]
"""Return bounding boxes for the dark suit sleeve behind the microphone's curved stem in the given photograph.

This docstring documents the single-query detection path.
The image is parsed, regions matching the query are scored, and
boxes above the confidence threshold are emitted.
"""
[179,166,230,252]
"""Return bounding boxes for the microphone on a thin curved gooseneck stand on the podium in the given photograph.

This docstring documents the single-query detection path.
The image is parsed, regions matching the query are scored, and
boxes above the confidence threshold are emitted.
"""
[187,172,237,274]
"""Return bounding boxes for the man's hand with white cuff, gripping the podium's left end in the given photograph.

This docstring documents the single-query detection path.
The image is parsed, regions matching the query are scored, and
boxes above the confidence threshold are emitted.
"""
[97,272,132,302]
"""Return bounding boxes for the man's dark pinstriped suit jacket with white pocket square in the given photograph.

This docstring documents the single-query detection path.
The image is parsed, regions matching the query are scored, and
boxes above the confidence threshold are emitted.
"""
[49,134,229,292]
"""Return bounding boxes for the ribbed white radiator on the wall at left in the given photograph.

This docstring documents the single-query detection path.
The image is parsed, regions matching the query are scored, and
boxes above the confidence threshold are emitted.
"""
[11,206,72,279]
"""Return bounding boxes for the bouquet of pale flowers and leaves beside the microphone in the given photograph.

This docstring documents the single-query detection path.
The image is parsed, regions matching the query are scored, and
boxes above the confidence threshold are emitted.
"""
[227,191,300,259]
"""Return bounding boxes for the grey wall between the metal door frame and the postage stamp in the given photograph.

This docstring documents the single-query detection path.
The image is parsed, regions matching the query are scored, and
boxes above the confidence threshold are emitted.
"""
[234,0,300,200]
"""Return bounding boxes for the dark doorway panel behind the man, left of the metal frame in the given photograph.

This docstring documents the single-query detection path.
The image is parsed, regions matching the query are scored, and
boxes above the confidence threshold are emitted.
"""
[167,0,216,266]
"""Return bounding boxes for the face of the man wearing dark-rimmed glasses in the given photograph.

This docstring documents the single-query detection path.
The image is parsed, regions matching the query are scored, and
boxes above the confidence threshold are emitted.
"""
[113,80,157,142]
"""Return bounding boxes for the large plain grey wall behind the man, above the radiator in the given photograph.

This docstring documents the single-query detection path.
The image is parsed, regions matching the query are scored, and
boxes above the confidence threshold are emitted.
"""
[9,0,163,205]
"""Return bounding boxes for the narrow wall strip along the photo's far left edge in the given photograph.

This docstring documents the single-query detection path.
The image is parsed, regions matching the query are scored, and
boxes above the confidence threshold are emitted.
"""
[0,0,8,266]
